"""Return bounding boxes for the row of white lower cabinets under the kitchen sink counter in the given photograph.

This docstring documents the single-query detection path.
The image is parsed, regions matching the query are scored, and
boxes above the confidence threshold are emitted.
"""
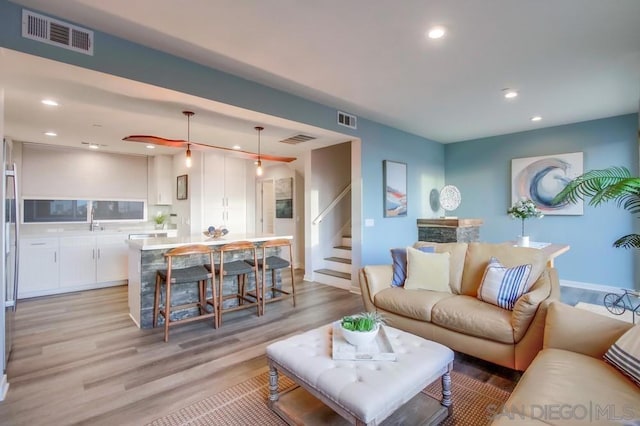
[18,234,128,298]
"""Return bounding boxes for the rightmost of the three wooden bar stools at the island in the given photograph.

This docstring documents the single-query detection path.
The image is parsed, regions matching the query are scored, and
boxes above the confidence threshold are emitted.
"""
[247,238,296,314]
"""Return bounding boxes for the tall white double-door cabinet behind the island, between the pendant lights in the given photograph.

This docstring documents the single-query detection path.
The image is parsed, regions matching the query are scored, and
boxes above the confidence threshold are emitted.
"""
[203,152,248,233]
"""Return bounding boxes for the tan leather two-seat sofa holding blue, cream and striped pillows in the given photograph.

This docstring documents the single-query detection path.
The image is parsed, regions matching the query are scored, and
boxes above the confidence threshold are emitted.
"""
[359,242,560,371]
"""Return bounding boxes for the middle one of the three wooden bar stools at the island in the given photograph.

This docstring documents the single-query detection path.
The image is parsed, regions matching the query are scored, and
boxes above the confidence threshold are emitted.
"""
[210,241,262,325]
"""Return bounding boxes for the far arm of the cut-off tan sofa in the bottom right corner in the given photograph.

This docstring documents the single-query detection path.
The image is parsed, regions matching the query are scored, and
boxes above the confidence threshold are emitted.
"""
[544,302,633,358]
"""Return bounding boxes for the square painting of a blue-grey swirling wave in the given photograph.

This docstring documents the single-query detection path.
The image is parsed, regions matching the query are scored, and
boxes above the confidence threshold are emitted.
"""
[511,152,584,215]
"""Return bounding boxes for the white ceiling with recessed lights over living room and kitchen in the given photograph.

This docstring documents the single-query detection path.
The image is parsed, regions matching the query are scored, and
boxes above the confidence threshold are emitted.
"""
[4,0,640,153]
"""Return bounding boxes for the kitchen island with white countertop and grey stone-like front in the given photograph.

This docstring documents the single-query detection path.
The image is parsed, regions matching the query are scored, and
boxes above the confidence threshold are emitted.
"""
[128,234,293,328]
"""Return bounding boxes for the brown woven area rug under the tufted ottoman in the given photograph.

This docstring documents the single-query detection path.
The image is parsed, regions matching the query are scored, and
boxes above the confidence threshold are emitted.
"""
[147,371,509,426]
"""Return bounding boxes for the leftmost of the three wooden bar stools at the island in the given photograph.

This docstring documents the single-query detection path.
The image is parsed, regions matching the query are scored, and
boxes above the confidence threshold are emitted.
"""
[153,244,219,342]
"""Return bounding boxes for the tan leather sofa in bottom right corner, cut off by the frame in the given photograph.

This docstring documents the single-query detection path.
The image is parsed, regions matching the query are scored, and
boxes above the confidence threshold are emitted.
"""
[490,302,640,426]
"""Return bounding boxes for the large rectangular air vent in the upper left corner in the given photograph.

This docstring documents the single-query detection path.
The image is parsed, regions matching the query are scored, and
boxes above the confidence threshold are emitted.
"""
[22,9,93,56]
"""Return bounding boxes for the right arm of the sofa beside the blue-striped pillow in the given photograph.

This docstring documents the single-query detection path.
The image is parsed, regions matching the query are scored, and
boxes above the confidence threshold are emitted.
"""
[511,268,560,343]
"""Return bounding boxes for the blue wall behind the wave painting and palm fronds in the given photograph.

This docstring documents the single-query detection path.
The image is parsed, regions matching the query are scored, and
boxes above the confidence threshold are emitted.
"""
[445,114,638,288]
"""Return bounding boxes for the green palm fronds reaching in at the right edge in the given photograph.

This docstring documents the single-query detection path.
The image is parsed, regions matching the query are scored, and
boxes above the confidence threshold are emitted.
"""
[553,166,640,248]
